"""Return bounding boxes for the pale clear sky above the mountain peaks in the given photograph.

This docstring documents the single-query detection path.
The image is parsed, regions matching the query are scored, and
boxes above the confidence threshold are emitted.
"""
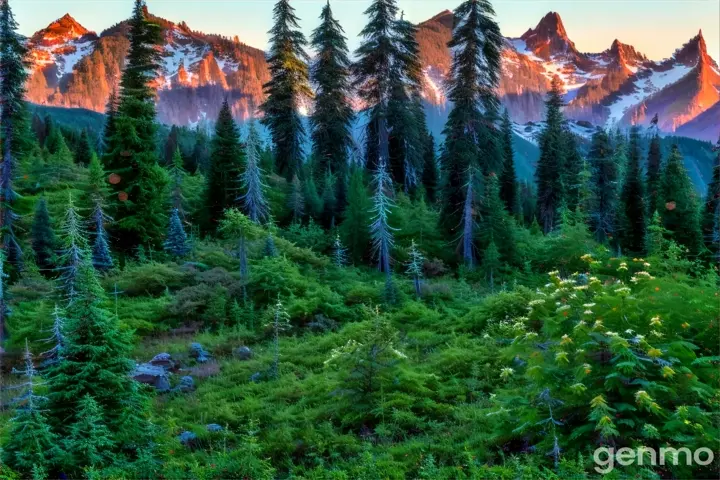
[10,0,720,60]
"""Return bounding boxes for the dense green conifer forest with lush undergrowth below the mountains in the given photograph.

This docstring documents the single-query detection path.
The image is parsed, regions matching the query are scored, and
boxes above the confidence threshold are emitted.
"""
[0,0,720,480]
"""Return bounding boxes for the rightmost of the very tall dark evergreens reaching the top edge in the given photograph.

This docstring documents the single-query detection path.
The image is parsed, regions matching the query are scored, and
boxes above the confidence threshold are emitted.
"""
[441,0,503,233]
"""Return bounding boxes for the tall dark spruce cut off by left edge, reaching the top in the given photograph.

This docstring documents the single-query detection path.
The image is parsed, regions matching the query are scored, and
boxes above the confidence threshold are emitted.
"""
[0,0,30,271]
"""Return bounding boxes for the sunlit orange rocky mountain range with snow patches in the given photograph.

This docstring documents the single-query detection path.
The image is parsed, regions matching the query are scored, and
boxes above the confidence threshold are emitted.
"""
[27,11,720,141]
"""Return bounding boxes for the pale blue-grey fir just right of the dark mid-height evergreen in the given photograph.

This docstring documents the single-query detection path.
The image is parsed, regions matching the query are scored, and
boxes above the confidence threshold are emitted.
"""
[237,121,270,223]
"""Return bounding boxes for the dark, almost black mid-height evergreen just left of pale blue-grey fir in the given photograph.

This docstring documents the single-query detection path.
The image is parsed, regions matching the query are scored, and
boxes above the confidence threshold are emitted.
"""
[205,99,245,232]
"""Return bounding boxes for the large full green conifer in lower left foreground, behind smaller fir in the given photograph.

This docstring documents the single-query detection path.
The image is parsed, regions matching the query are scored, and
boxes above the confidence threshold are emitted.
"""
[46,260,148,438]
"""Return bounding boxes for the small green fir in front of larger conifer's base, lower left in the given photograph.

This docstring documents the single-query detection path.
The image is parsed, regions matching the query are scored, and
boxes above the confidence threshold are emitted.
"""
[65,394,115,470]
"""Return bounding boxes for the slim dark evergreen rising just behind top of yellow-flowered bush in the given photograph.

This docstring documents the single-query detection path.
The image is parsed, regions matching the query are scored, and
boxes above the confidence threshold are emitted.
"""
[619,126,647,253]
